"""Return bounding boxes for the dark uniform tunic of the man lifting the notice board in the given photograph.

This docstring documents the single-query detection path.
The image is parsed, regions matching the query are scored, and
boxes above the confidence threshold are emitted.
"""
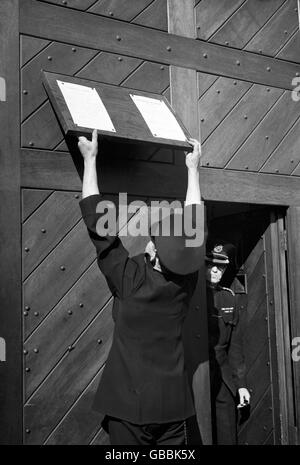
[80,195,197,424]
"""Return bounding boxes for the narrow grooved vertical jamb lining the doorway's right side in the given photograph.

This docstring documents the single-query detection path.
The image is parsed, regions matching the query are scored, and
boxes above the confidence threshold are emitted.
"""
[266,209,297,445]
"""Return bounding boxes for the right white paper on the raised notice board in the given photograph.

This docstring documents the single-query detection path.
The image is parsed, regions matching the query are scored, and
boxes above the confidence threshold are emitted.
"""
[130,94,186,141]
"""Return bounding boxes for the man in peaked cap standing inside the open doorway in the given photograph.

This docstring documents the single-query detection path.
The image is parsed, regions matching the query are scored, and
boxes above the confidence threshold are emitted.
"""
[206,239,250,444]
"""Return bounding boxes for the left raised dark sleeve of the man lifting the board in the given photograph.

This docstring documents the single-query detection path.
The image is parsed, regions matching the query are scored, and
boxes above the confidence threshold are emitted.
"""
[79,194,144,298]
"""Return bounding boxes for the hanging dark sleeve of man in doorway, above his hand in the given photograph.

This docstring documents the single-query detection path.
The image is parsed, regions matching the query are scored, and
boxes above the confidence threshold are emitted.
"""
[228,310,247,389]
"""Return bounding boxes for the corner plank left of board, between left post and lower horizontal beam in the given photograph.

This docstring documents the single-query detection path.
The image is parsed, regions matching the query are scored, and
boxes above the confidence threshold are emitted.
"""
[21,100,63,150]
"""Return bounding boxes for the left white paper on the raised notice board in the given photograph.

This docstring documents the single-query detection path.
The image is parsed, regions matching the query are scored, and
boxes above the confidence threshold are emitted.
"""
[57,80,116,132]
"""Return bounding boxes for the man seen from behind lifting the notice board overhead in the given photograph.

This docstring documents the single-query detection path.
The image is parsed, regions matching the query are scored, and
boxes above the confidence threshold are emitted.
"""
[78,131,204,445]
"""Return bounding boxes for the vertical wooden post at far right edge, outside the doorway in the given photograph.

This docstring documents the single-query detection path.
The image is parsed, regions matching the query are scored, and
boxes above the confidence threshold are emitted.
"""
[287,206,300,445]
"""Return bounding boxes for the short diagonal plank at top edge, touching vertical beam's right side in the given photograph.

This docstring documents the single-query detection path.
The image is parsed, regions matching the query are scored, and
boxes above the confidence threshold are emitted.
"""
[196,0,245,40]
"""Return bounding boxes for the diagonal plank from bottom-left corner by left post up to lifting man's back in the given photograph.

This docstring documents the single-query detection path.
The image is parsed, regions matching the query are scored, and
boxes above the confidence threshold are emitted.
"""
[24,302,113,444]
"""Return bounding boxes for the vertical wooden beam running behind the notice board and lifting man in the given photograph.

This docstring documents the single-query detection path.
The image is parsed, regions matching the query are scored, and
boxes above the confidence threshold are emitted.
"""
[168,0,211,444]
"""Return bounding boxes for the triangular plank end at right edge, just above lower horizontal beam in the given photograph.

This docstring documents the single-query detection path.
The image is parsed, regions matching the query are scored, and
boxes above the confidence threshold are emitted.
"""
[260,119,300,174]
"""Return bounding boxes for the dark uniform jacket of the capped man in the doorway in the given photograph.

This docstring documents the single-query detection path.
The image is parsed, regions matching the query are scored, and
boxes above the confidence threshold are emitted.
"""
[207,286,246,395]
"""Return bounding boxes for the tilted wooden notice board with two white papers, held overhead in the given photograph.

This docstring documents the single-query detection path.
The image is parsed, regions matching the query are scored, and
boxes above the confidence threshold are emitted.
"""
[42,71,191,150]
